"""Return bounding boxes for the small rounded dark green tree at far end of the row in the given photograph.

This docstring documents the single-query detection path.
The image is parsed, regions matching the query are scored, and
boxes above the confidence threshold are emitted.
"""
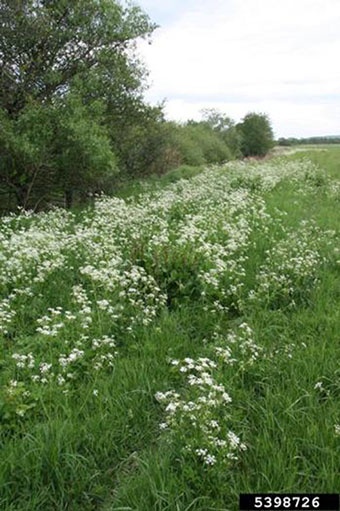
[237,113,274,156]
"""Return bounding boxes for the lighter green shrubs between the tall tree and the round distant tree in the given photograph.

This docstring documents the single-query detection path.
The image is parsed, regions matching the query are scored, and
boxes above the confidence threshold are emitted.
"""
[111,113,235,176]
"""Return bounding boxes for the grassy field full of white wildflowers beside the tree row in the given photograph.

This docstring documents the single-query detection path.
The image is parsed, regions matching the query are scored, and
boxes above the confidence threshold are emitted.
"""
[0,148,340,511]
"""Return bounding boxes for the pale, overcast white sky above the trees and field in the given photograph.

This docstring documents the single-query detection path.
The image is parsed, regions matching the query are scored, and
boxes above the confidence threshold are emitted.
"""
[134,0,340,138]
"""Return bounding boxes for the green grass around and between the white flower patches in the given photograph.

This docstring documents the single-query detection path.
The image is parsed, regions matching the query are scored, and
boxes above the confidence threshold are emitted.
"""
[0,148,340,511]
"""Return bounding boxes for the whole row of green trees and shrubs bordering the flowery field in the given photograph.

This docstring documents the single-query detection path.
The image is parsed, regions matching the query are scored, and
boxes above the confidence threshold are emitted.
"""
[0,0,273,210]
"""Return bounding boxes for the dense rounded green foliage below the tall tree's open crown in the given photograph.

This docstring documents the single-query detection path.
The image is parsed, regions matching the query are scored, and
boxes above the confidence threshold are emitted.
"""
[0,95,117,208]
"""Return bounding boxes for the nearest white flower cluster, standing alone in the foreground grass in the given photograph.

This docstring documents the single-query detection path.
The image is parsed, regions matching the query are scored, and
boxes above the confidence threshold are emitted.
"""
[155,357,246,466]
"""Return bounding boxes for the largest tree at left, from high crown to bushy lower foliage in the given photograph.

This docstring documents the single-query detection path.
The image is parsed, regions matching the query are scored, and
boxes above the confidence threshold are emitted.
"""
[0,0,155,207]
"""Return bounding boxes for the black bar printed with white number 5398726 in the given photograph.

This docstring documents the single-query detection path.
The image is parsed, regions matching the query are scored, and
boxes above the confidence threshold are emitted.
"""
[240,493,339,511]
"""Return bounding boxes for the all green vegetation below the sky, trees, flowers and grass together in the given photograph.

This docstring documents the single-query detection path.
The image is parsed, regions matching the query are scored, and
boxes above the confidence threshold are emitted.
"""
[0,0,340,511]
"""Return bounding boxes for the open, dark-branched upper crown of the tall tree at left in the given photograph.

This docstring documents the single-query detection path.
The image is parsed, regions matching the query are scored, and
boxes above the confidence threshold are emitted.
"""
[0,0,154,117]
